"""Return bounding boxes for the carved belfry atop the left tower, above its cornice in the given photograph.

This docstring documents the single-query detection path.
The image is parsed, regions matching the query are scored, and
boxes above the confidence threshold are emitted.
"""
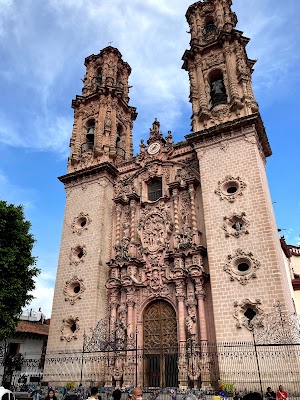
[68,46,137,173]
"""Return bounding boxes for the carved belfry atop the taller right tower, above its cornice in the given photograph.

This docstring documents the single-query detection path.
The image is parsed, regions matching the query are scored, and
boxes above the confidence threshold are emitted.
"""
[183,0,258,132]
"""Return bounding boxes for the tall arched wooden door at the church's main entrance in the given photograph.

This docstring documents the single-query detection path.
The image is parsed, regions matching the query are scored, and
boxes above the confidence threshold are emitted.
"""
[143,300,178,387]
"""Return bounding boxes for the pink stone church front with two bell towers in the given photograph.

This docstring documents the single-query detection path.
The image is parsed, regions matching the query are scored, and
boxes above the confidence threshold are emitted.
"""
[44,0,293,387]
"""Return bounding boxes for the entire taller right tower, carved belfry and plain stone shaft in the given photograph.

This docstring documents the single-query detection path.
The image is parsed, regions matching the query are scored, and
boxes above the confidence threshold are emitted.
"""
[183,0,293,342]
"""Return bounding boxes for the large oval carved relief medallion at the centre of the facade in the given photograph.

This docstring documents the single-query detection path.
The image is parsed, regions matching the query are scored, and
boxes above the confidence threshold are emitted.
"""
[138,203,173,253]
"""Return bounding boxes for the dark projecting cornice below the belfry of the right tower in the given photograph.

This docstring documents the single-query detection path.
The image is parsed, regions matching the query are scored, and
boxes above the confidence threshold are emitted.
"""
[186,113,272,157]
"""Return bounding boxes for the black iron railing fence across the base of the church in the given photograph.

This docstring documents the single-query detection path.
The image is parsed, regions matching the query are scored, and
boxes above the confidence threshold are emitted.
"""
[39,342,300,396]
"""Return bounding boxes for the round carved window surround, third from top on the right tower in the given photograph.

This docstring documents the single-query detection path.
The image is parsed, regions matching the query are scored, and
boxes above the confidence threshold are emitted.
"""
[224,249,260,285]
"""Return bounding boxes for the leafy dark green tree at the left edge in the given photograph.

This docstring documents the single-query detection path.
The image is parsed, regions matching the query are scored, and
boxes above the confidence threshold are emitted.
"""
[0,200,40,340]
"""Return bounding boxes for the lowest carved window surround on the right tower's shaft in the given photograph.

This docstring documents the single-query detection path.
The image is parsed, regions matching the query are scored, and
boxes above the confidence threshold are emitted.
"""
[232,299,264,331]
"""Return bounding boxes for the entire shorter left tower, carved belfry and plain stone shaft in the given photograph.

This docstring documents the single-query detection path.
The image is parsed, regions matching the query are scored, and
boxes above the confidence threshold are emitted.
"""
[44,47,137,382]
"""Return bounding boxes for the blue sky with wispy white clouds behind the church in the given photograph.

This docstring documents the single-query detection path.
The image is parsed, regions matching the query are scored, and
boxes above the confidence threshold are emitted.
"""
[0,0,300,317]
